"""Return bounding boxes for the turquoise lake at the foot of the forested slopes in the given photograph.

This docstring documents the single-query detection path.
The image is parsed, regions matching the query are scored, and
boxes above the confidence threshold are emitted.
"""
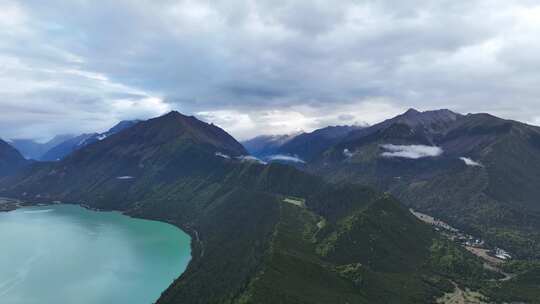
[0,205,191,304]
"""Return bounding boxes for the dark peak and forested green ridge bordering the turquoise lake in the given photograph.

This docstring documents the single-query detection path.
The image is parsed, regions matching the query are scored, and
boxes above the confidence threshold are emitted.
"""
[0,112,506,304]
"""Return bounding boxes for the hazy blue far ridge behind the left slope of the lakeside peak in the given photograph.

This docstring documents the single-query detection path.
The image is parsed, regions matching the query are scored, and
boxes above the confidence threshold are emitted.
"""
[40,120,139,161]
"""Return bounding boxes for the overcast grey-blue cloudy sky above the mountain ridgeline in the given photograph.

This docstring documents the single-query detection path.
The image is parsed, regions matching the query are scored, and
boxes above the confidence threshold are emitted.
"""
[0,0,540,140]
